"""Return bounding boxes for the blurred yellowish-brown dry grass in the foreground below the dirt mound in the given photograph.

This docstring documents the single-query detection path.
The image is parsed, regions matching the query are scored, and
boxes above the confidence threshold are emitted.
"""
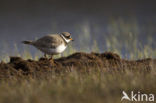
[0,68,156,103]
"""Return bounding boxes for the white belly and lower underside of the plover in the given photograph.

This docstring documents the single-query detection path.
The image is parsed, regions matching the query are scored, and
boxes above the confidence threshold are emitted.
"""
[40,44,67,54]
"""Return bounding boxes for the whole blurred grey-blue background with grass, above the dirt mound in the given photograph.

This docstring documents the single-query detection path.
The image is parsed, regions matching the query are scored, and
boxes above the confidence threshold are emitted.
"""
[0,0,156,60]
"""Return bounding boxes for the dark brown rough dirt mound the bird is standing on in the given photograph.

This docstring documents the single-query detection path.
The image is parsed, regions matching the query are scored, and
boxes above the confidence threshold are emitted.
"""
[0,52,156,78]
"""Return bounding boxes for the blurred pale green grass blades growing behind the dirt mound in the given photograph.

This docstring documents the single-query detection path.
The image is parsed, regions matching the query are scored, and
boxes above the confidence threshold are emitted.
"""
[0,17,156,62]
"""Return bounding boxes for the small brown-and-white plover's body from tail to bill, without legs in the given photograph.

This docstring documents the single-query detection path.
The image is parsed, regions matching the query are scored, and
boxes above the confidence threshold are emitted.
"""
[22,32,72,55]
